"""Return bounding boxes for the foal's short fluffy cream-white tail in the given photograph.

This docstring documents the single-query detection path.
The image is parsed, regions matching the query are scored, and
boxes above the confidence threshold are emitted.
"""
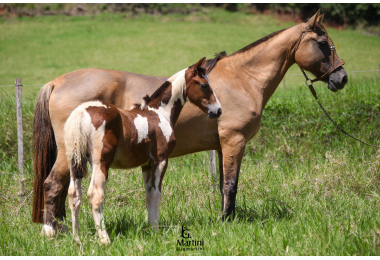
[64,103,91,179]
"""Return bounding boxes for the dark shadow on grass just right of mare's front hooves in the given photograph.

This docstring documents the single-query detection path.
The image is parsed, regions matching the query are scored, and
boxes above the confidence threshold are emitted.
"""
[236,198,294,222]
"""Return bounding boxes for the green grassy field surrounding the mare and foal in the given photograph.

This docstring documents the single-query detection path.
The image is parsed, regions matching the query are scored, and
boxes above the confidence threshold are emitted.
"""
[0,11,380,255]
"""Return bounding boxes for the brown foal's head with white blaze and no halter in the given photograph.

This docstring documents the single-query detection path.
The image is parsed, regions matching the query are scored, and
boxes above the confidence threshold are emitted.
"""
[185,57,222,118]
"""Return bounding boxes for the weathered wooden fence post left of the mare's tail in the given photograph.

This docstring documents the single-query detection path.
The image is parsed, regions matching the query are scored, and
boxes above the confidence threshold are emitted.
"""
[15,79,25,197]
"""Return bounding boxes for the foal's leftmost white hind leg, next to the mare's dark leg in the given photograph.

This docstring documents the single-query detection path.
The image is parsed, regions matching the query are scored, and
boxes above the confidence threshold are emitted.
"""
[68,172,82,241]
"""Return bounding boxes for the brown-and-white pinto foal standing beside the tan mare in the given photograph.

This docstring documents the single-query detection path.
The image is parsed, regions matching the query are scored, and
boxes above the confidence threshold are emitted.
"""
[64,58,222,244]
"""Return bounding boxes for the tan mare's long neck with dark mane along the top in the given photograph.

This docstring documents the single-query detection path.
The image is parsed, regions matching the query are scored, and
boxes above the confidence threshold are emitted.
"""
[220,25,301,109]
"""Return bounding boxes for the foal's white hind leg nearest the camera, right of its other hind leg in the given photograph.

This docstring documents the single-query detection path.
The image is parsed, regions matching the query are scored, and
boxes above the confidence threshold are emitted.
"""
[87,162,111,244]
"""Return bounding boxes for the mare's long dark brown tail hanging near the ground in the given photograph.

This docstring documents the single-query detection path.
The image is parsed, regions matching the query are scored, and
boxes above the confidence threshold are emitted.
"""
[32,82,57,223]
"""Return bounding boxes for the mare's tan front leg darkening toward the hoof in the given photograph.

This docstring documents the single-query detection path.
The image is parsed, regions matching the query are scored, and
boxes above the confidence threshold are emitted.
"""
[218,131,245,221]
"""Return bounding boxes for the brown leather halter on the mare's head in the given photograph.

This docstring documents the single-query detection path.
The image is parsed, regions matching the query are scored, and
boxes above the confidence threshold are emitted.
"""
[294,24,344,83]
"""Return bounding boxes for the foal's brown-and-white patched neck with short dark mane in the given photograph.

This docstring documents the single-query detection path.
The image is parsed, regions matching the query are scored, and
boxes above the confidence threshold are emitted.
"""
[147,70,186,126]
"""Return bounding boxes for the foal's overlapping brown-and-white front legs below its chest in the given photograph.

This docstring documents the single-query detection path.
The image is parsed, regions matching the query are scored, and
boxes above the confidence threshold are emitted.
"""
[141,158,168,227]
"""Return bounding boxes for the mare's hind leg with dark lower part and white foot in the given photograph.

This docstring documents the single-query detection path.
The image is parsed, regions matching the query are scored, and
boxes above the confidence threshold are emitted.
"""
[42,149,70,237]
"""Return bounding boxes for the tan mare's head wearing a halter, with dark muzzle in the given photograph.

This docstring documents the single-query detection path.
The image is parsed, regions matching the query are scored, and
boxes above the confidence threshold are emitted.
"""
[294,11,348,92]
